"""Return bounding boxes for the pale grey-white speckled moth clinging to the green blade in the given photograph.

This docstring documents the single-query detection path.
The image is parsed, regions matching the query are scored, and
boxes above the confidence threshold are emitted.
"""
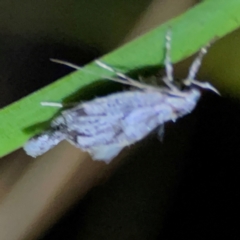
[24,31,218,163]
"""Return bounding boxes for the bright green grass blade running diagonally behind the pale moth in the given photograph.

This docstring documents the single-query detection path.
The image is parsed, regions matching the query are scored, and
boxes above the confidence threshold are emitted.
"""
[0,0,240,156]
